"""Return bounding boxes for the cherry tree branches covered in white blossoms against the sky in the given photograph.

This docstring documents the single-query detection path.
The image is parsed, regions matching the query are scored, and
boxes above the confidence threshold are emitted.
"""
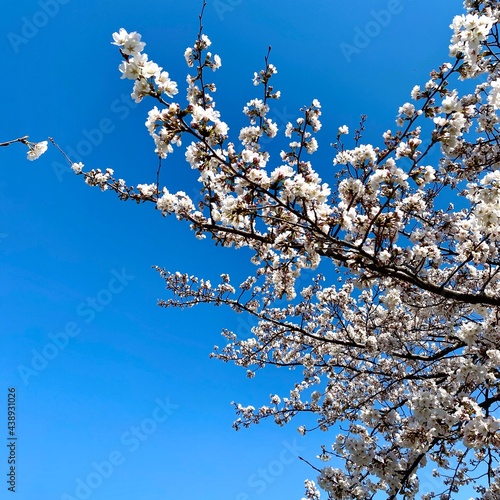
[6,0,500,500]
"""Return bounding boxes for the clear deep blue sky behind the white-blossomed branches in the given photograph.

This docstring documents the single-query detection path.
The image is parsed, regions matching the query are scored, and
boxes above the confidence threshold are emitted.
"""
[0,0,461,500]
